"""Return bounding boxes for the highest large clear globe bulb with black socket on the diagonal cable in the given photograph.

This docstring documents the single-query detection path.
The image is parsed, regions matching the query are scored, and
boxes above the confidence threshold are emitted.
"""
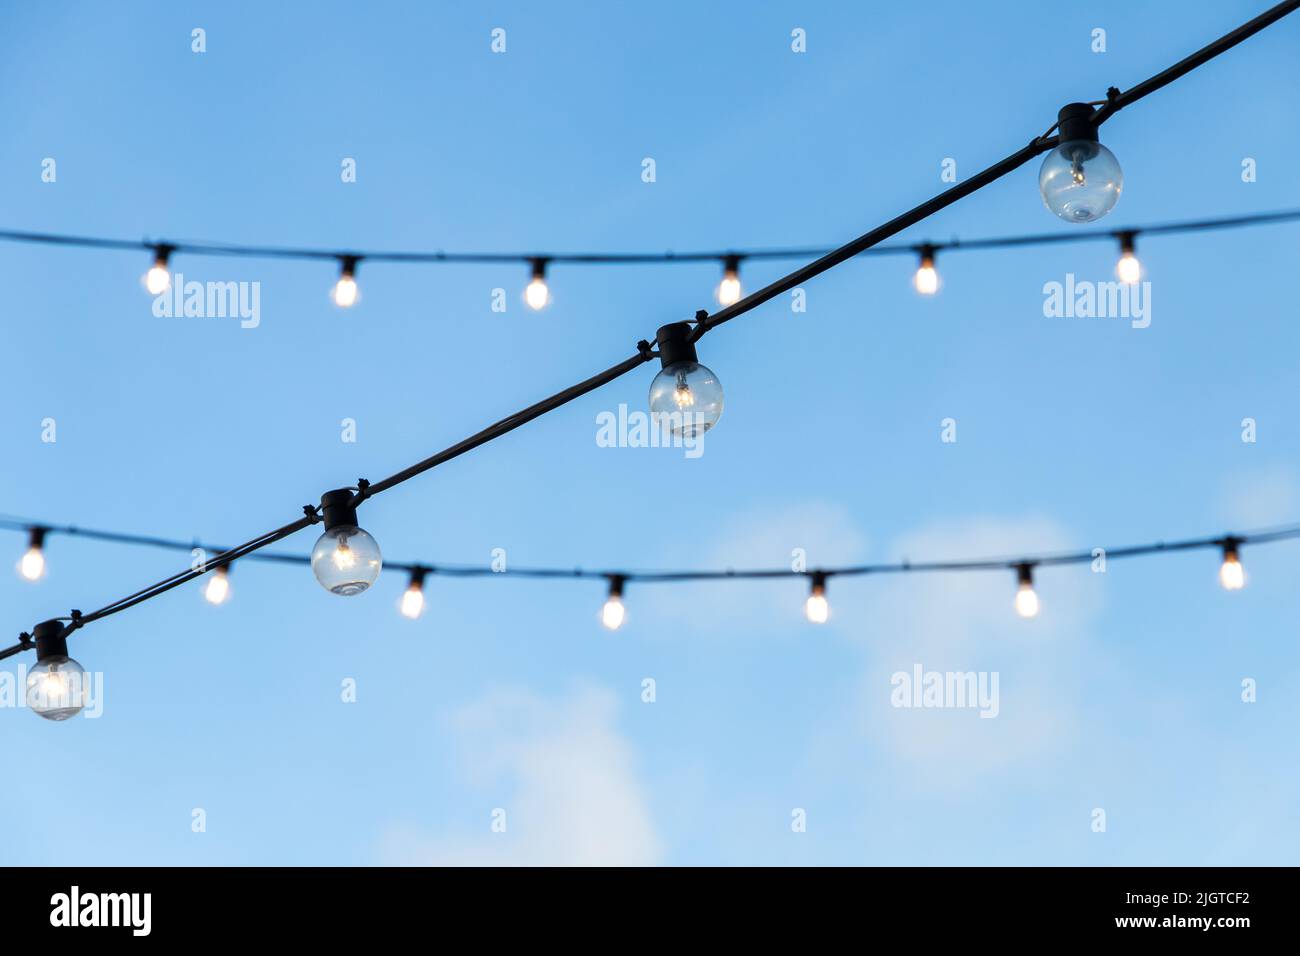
[1039,103,1125,222]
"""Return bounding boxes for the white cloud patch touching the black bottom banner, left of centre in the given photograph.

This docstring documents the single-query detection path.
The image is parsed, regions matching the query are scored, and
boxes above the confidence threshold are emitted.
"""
[381,688,662,866]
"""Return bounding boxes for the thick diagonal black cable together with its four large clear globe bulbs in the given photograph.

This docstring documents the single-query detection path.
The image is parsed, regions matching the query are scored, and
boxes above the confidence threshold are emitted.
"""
[0,0,1300,719]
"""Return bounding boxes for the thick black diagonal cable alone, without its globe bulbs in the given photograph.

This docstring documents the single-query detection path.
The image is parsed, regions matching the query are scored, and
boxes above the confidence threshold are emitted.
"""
[0,0,1300,659]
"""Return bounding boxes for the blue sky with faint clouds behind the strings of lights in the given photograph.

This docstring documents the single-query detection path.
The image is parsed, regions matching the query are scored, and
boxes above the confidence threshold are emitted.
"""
[0,1,1300,865]
